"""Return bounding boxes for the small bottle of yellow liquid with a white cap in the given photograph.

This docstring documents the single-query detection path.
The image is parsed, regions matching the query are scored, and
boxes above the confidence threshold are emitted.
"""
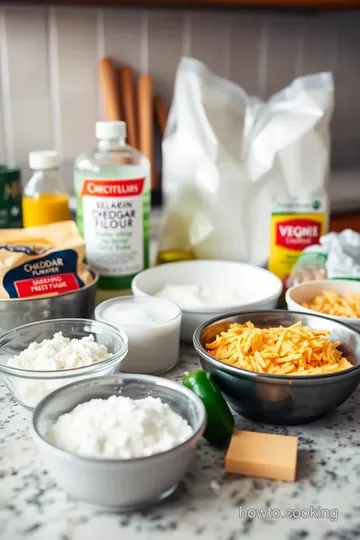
[22,150,70,227]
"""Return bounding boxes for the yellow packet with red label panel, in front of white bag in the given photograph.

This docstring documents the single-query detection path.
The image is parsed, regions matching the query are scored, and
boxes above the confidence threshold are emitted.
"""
[269,199,327,285]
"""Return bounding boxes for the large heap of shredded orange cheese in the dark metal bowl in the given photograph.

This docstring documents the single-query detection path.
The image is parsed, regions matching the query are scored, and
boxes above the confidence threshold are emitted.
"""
[205,322,352,375]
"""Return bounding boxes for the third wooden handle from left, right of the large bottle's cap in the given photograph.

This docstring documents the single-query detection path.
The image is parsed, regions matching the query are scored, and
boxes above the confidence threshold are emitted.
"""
[138,73,158,189]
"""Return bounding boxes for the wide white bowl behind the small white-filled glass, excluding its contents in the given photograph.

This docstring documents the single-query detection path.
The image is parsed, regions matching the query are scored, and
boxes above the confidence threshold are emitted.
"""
[131,260,282,342]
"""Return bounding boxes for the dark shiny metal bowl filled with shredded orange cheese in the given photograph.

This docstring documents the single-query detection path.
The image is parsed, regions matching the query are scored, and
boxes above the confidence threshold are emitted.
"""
[194,310,360,424]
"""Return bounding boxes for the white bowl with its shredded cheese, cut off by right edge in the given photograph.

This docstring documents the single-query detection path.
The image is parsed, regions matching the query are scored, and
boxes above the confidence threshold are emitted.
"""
[285,279,360,330]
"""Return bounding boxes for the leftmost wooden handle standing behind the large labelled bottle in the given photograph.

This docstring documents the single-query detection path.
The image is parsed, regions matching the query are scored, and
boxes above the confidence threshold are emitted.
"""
[99,57,122,121]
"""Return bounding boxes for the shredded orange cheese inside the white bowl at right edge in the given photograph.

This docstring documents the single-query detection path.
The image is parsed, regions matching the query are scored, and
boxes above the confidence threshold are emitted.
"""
[301,291,360,318]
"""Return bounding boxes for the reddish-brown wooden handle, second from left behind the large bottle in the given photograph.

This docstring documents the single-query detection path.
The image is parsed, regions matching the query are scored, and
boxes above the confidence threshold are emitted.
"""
[119,66,138,148]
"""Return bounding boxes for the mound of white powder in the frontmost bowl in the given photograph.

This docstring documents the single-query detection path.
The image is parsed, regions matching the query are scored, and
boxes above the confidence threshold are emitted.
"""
[47,396,193,459]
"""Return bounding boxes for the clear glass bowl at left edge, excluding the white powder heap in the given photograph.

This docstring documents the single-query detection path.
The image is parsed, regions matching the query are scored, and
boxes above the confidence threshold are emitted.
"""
[0,319,128,411]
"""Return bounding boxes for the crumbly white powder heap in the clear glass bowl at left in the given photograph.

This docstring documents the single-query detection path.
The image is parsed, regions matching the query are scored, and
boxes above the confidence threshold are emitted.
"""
[7,332,111,371]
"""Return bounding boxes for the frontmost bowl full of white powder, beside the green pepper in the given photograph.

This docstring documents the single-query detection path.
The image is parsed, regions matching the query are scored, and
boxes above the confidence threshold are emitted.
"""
[32,374,206,511]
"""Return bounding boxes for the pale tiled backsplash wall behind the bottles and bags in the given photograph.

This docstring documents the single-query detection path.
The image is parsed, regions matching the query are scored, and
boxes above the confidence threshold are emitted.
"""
[0,2,360,199]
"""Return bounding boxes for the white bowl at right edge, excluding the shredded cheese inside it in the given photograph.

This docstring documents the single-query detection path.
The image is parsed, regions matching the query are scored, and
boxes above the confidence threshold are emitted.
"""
[285,279,360,330]
